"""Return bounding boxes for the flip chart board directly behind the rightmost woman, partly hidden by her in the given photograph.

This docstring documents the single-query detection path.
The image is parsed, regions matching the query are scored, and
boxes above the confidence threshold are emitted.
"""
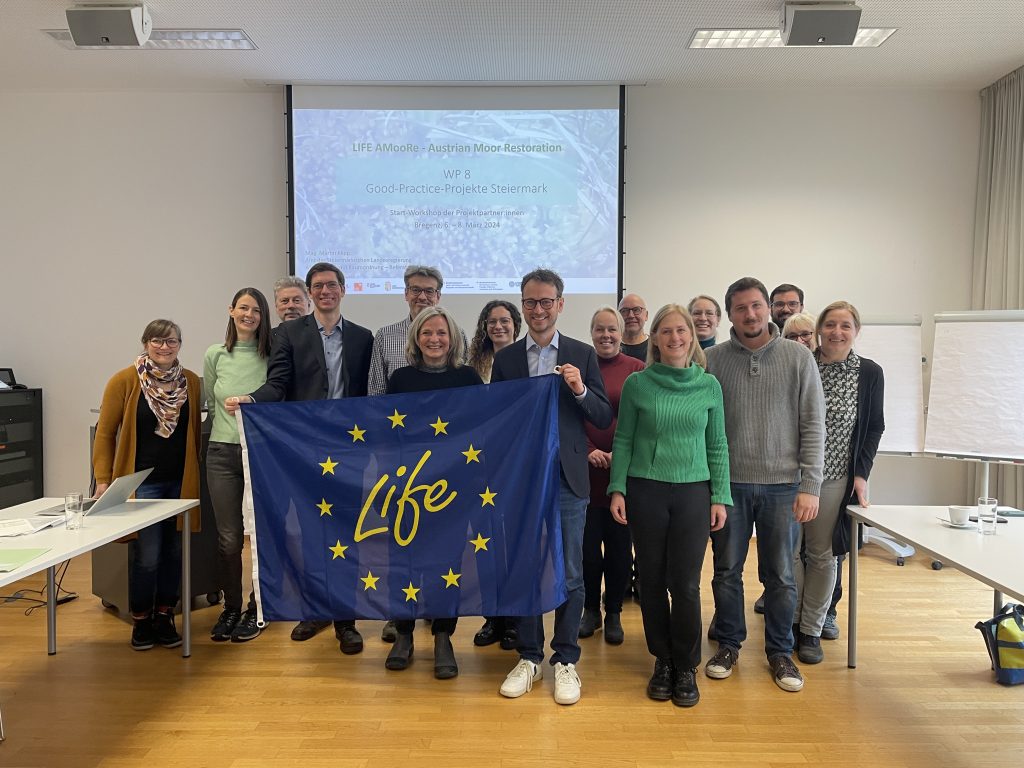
[853,317,925,454]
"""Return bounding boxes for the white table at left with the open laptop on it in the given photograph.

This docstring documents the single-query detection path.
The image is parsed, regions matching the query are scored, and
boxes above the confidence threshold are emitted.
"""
[0,499,199,740]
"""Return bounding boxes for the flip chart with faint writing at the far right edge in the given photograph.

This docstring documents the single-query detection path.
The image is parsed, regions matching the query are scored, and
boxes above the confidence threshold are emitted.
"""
[925,310,1024,461]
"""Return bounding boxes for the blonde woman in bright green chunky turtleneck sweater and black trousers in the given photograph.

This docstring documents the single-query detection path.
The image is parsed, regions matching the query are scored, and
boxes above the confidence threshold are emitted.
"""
[608,304,732,707]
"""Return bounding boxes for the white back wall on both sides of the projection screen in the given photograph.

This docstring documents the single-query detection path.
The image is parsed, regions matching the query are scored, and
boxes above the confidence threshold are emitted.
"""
[0,87,978,503]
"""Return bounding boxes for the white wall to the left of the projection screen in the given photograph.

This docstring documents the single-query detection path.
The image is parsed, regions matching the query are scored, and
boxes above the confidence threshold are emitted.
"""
[0,93,288,495]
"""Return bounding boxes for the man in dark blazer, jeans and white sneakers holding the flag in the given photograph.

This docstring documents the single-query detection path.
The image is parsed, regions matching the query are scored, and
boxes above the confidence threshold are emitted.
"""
[490,269,611,705]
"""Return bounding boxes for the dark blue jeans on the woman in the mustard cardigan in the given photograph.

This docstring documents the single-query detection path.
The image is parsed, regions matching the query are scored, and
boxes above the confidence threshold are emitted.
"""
[128,480,188,616]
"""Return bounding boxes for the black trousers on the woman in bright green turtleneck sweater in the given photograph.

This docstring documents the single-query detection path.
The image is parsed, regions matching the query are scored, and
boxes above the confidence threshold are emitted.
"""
[626,477,711,670]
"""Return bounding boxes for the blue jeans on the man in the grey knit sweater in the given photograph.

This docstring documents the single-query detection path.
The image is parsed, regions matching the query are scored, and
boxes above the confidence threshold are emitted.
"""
[711,482,800,658]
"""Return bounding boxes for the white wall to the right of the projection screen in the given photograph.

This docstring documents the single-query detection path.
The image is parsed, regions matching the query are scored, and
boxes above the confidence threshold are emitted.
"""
[624,87,979,504]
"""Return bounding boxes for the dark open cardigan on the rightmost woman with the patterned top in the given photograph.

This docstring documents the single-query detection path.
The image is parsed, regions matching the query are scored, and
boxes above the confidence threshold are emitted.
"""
[833,357,886,555]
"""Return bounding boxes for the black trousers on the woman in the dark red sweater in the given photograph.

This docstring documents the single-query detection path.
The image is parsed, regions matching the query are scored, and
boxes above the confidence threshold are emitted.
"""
[583,505,633,613]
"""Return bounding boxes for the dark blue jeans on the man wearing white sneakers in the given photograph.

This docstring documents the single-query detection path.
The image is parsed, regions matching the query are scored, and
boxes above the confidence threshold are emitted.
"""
[517,477,588,664]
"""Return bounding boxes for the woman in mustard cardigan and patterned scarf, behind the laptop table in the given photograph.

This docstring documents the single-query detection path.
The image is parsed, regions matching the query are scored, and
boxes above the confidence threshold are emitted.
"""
[92,319,202,650]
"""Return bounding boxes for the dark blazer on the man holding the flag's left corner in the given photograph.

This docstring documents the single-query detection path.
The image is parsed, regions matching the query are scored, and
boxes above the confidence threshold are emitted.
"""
[252,314,374,402]
